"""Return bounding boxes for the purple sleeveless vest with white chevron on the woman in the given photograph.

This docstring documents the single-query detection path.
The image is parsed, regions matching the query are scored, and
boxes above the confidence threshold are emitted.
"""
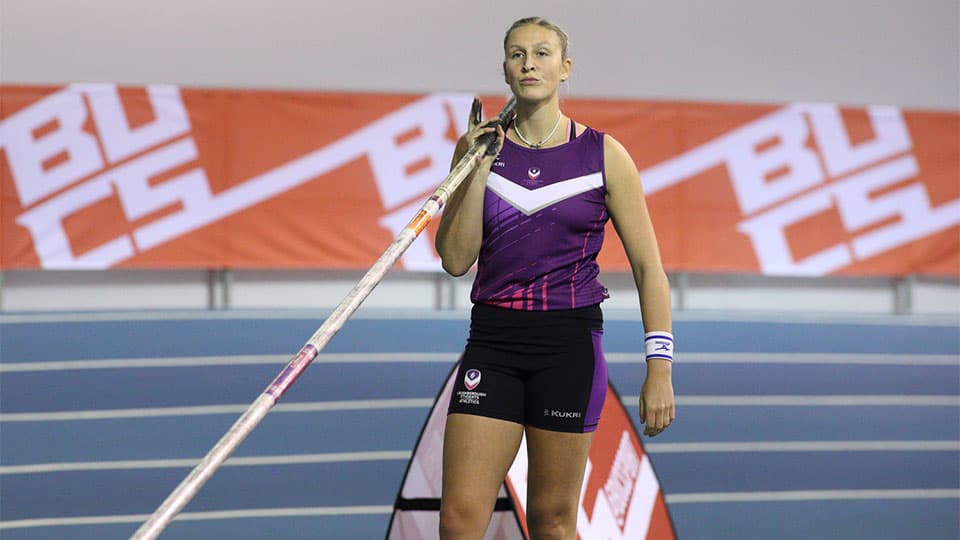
[470,128,609,311]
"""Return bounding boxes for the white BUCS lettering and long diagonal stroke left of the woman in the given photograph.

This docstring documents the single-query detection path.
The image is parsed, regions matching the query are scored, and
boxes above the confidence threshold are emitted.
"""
[0,89,471,269]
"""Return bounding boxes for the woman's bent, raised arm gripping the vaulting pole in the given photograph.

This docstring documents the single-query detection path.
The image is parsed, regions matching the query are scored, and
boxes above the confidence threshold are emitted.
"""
[434,122,504,276]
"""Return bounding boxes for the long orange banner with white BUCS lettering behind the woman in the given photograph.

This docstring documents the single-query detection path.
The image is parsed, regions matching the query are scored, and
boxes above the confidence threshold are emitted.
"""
[0,84,960,276]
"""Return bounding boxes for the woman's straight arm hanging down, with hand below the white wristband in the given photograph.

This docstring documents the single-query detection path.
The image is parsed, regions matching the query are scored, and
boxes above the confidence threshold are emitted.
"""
[603,135,676,436]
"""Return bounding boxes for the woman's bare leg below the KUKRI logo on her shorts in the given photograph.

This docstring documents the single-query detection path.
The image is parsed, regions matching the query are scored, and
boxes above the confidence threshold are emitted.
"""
[526,426,593,540]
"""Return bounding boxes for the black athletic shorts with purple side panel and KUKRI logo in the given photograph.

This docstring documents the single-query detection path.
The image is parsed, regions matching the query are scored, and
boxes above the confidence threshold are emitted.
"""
[448,304,607,433]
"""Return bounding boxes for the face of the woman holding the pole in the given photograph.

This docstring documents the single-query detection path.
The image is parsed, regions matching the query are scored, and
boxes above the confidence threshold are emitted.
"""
[503,24,572,101]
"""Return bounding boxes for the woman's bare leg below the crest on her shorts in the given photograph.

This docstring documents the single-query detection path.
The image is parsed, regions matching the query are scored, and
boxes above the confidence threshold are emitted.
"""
[440,414,523,540]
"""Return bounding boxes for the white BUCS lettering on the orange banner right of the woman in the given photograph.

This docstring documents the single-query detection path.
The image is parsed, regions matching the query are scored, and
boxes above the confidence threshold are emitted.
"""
[641,104,960,276]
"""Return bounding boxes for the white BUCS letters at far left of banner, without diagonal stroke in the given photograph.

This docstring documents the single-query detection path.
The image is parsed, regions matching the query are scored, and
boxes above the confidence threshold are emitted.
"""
[0,84,200,268]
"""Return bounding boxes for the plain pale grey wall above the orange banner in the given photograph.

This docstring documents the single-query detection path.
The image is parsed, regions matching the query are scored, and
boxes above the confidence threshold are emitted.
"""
[0,0,960,109]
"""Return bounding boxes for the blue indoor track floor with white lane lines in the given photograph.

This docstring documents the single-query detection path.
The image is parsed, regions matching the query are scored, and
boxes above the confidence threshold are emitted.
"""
[0,310,960,540]
